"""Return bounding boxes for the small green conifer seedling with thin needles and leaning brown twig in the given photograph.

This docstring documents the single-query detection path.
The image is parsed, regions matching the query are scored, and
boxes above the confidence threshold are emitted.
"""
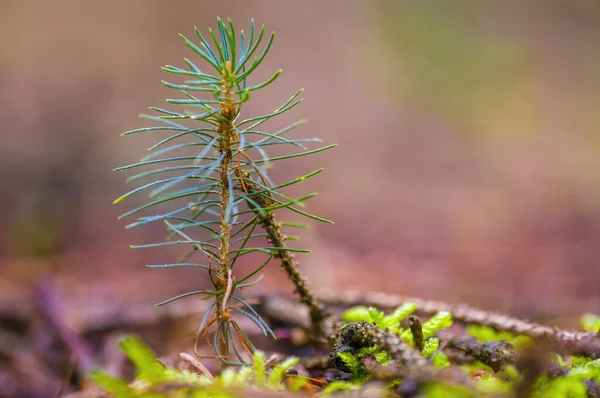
[115,19,333,365]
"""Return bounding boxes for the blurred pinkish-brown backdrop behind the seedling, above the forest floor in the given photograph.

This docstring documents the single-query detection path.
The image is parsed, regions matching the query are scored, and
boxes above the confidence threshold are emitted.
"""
[0,0,600,390]
